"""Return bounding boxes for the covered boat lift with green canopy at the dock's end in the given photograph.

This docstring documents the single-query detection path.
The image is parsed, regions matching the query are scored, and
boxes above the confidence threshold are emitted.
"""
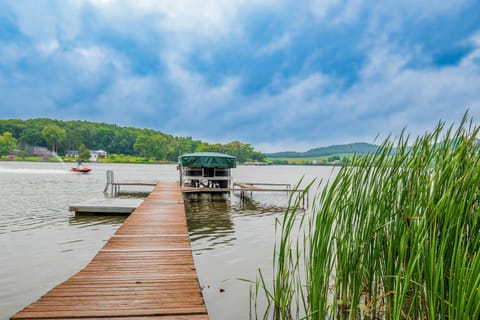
[178,152,237,188]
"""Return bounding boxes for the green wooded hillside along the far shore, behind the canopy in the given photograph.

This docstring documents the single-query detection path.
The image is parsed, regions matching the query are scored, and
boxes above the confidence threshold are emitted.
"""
[0,118,266,162]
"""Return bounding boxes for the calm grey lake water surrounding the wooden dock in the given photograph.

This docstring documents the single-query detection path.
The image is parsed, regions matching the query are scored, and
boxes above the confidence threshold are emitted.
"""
[0,161,332,320]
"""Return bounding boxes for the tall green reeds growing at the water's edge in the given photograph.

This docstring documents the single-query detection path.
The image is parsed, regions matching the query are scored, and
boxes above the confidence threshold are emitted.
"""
[252,116,480,320]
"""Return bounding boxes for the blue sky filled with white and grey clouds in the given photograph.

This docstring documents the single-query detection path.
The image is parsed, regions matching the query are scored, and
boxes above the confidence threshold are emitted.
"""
[0,0,480,152]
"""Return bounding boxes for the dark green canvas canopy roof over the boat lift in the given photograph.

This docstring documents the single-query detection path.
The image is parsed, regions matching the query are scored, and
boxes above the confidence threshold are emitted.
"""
[178,152,237,169]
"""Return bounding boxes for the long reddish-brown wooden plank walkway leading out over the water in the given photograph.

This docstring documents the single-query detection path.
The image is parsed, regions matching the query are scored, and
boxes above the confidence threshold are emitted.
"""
[11,183,208,320]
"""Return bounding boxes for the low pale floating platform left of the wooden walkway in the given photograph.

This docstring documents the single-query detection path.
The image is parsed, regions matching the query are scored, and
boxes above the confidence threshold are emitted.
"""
[69,198,143,214]
